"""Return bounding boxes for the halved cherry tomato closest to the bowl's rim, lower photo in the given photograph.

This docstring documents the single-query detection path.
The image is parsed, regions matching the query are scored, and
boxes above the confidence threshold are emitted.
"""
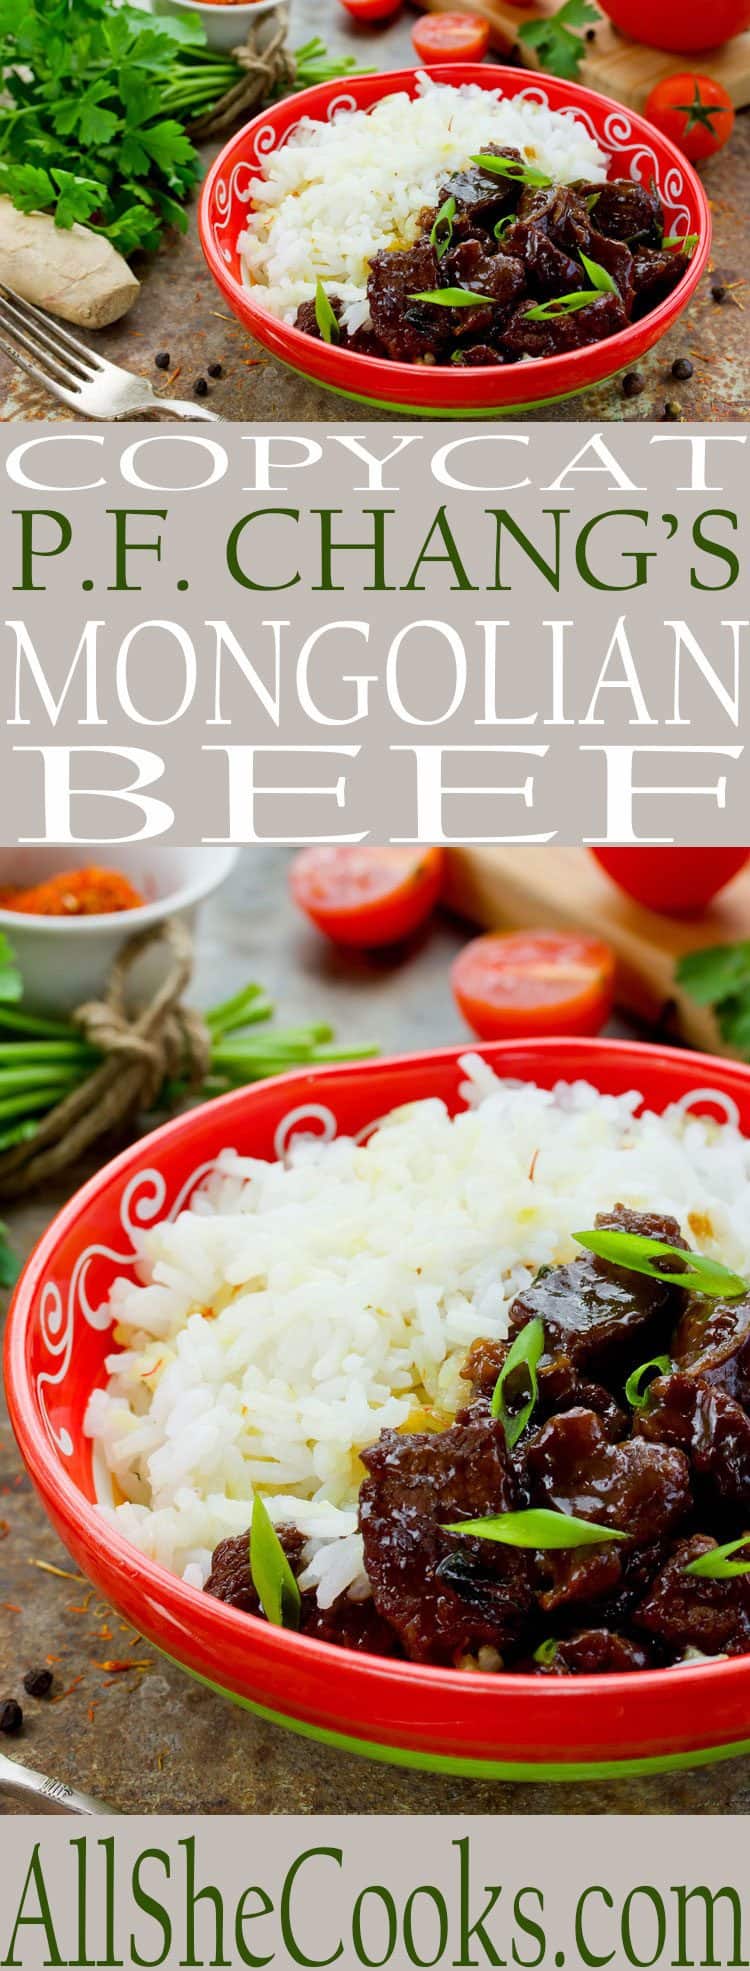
[451,930,614,1041]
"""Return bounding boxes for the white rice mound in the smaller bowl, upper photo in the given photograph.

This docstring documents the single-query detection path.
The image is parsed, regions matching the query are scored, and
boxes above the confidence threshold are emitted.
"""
[240,75,608,331]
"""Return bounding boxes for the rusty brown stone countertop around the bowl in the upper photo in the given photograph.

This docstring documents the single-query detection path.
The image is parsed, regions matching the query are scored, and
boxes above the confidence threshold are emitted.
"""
[0,0,750,426]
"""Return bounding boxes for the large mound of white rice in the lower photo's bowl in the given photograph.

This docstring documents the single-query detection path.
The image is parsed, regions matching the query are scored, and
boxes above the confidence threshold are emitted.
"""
[87,1054,750,1606]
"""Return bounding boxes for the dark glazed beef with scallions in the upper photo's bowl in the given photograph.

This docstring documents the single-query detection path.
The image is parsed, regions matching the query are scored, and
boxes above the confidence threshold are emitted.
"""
[295,161,689,369]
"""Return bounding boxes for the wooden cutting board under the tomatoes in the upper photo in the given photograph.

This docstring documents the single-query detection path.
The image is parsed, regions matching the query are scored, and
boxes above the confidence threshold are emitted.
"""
[417,0,750,110]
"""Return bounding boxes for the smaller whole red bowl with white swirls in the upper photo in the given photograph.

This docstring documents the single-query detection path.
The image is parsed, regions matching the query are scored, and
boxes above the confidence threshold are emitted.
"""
[199,63,711,418]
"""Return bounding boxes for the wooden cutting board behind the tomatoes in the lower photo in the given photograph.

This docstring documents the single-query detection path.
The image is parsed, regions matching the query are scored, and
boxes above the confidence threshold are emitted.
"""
[440,848,750,1054]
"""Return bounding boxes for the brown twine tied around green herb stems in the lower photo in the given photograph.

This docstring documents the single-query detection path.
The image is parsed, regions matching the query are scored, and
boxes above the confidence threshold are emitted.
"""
[0,917,211,1198]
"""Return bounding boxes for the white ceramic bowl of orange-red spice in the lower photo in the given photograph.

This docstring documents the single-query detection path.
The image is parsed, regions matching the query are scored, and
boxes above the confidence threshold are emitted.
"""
[0,844,238,1013]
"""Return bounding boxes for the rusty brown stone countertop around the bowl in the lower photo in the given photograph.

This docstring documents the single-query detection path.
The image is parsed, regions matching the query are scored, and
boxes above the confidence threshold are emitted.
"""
[0,850,750,1813]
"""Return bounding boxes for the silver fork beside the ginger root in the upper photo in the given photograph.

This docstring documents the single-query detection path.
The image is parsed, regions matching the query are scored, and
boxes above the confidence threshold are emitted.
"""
[0,282,222,424]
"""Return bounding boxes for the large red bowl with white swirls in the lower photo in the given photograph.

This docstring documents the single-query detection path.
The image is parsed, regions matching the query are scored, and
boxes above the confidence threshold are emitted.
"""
[6,1039,750,1780]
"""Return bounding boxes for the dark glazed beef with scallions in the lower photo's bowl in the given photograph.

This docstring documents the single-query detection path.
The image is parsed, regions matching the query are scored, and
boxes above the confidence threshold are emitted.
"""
[207,1198,750,1677]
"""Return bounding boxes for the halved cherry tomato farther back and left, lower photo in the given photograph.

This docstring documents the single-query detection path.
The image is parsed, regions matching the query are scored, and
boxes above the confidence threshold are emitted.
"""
[289,844,443,950]
